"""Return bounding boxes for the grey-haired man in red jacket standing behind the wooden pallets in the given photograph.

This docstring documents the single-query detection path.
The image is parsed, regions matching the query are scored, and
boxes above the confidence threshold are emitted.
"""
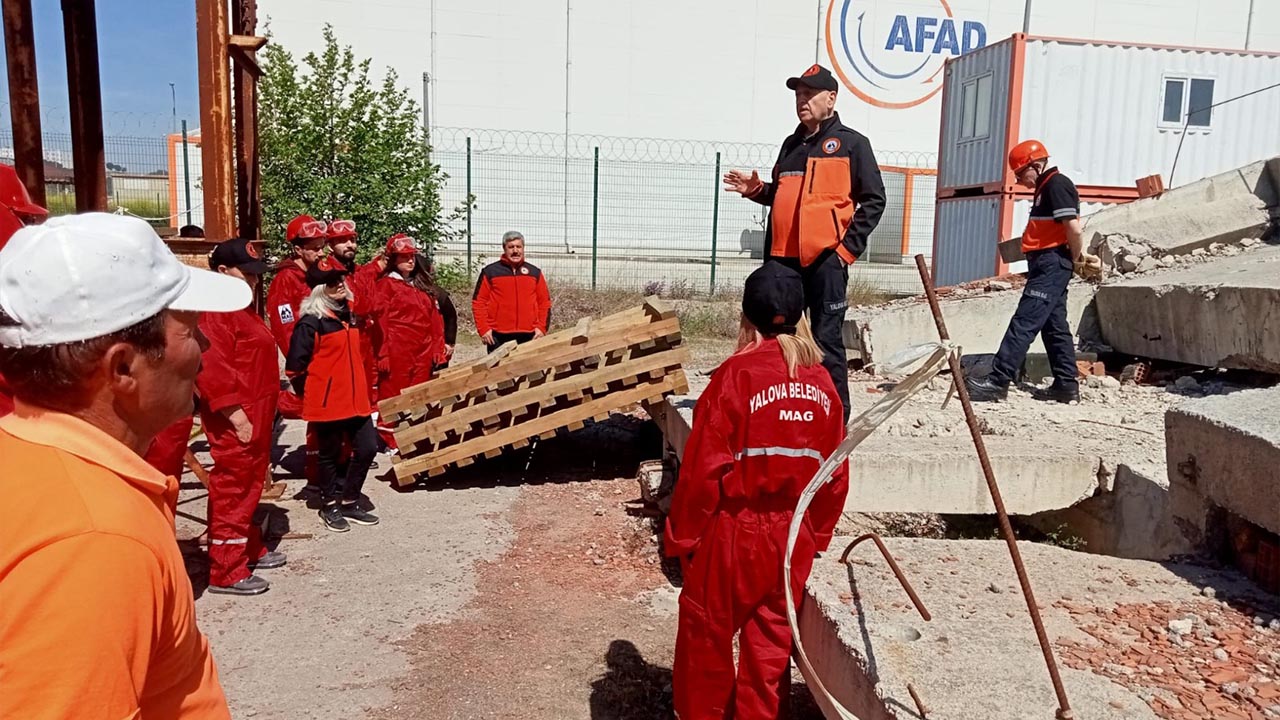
[471,231,552,351]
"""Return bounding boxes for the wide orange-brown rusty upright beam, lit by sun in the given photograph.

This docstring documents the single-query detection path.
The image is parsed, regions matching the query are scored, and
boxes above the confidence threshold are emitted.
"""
[196,0,237,241]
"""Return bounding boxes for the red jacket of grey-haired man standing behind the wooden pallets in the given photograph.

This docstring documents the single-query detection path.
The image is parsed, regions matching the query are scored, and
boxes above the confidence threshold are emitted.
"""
[471,258,552,334]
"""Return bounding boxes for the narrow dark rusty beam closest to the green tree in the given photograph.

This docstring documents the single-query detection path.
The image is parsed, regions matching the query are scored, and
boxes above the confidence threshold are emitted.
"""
[230,0,266,240]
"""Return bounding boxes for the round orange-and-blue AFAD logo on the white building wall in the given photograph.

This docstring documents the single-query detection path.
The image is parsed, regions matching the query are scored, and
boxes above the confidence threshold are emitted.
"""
[827,0,987,109]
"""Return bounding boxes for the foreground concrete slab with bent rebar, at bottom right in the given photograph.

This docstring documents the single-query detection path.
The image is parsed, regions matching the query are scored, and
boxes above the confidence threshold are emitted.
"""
[799,538,1261,720]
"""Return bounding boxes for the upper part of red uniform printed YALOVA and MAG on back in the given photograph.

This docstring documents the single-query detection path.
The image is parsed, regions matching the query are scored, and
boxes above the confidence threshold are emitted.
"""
[663,340,849,556]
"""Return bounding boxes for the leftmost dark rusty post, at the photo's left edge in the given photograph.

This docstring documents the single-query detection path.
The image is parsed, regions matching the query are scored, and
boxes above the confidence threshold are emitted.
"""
[4,0,47,208]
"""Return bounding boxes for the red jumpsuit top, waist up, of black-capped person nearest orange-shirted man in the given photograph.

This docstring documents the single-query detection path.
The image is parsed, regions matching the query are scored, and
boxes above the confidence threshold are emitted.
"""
[196,307,280,413]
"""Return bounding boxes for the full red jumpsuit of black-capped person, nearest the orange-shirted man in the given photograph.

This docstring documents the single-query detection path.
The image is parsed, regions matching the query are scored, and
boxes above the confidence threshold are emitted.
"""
[196,302,280,587]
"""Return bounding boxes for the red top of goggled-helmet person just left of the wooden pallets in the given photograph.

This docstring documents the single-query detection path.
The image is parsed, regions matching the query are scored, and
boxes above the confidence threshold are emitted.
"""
[374,274,444,381]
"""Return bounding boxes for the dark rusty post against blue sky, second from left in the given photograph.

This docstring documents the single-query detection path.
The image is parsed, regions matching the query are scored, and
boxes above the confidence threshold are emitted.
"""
[60,0,106,213]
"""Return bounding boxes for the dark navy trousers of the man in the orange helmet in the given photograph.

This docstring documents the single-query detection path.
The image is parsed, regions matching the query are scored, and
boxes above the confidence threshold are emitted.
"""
[989,246,1079,388]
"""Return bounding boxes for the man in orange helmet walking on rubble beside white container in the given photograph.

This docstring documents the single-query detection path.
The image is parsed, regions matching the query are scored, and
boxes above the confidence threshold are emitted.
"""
[965,140,1097,402]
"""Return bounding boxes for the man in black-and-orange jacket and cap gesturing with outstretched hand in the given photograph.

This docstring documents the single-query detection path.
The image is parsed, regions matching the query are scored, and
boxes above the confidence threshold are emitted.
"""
[724,65,884,423]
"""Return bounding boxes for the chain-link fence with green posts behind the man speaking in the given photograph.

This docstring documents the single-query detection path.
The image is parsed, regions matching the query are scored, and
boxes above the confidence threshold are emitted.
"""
[431,128,937,293]
